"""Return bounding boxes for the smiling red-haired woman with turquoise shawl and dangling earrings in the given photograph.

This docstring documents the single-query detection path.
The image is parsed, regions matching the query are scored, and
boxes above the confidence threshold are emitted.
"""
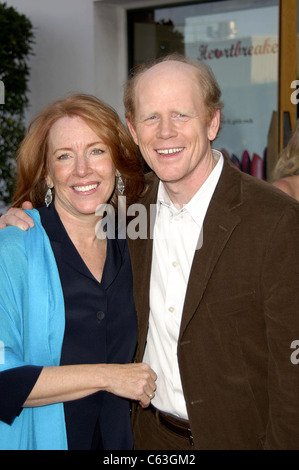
[0,94,156,449]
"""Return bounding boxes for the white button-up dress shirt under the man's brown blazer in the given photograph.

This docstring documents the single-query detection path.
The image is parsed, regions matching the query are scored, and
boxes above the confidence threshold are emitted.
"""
[143,150,223,419]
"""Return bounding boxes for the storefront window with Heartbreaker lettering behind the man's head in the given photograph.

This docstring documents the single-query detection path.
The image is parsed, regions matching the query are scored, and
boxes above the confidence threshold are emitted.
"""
[128,0,278,178]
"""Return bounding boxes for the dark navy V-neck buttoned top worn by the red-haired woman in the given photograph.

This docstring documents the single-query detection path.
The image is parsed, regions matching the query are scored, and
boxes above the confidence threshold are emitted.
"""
[0,204,137,450]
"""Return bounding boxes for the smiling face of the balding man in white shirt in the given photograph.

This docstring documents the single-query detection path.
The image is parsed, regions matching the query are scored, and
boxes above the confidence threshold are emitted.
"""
[128,61,219,196]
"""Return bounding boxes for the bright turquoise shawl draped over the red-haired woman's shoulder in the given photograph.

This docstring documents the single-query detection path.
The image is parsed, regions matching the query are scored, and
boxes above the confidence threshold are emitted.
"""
[0,210,67,450]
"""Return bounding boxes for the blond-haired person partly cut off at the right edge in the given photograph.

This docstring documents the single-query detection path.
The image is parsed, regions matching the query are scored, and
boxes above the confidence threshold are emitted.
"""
[272,121,299,201]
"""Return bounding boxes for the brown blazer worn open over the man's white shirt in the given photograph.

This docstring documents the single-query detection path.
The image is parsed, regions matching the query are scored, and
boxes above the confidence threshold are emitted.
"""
[129,156,299,449]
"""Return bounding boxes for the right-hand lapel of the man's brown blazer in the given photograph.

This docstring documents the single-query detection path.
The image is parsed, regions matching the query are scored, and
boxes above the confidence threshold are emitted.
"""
[180,160,242,337]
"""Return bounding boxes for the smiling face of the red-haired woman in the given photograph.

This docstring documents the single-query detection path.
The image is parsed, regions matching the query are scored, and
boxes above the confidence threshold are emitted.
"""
[46,116,116,217]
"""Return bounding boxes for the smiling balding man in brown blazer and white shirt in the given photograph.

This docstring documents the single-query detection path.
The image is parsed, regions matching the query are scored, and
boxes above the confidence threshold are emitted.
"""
[1,56,299,450]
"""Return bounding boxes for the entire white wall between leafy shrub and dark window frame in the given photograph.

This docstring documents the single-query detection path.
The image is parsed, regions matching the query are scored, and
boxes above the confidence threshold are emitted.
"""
[6,0,192,124]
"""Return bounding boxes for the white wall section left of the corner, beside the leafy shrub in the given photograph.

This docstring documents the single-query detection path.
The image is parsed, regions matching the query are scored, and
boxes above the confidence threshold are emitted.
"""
[7,0,95,125]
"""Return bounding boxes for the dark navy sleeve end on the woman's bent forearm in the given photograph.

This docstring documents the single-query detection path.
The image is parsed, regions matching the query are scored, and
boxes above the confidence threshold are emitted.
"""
[0,366,43,424]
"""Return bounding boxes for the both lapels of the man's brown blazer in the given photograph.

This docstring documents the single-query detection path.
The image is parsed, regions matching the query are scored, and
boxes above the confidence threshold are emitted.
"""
[128,159,242,348]
